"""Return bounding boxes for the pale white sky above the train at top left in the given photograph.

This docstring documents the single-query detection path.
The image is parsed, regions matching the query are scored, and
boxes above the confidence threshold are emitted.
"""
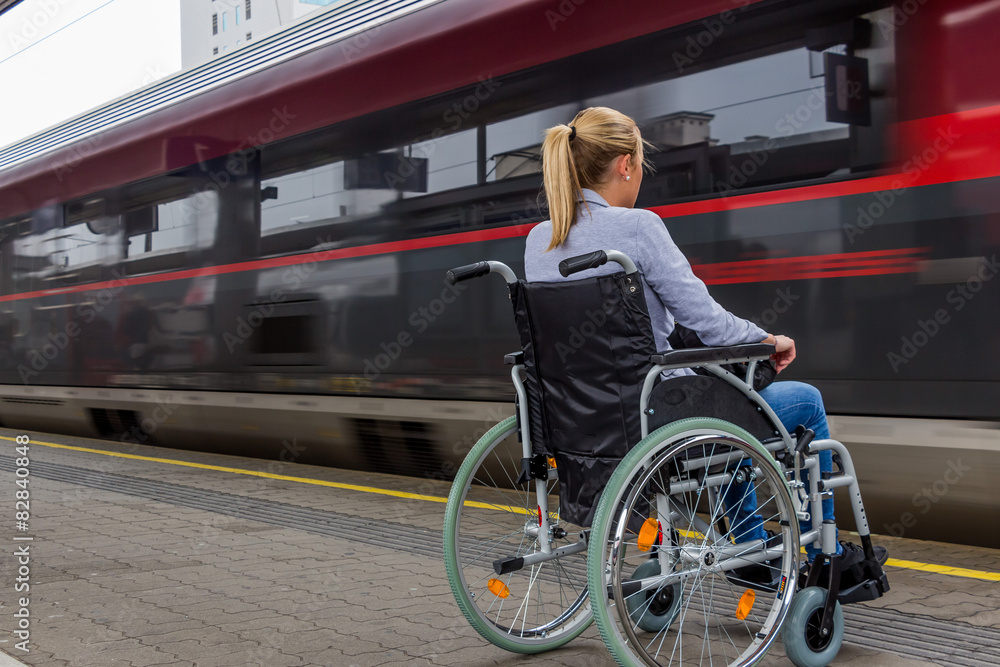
[0,0,181,147]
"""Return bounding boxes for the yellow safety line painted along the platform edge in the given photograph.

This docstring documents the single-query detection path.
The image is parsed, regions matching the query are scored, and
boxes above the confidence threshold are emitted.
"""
[9,435,1000,582]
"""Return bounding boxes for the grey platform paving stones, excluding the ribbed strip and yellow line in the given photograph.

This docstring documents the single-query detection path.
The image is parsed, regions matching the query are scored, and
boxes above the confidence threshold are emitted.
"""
[0,429,1000,667]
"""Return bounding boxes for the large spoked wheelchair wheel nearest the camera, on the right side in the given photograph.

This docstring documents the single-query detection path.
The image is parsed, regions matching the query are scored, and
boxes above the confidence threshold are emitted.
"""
[588,419,799,666]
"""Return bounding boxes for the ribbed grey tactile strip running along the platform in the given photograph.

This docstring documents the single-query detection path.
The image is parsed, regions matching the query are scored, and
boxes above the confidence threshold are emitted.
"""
[0,456,1000,667]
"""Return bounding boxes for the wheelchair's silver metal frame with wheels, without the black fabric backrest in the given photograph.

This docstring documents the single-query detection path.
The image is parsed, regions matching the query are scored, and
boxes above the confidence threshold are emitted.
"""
[445,250,888,667]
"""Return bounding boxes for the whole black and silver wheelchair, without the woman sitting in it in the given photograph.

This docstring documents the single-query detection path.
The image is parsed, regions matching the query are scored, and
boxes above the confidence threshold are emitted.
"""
[444,250,889,667]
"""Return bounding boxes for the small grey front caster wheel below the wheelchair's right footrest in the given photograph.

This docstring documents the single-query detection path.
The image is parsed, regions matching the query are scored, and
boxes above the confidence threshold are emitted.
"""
[781,586,844,667]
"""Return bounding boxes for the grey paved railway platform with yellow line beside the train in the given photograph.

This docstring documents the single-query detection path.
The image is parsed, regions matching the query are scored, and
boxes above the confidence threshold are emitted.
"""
[0,429,1000,667]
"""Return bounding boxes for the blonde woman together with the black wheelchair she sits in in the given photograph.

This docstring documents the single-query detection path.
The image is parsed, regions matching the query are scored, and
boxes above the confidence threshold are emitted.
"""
[444,108,889,667]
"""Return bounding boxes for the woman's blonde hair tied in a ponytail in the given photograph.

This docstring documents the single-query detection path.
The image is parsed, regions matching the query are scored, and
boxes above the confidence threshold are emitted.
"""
[542,107,647,252]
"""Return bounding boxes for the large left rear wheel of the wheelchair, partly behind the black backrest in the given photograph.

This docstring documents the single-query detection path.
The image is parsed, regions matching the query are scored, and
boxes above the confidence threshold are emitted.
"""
[444,417,593,653]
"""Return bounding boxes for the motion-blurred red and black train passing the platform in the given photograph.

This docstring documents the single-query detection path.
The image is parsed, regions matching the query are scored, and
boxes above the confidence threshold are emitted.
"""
[0,0,1000,546]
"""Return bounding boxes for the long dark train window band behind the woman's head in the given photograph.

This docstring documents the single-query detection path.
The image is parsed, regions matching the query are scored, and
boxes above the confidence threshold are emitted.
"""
[248,5,894,255]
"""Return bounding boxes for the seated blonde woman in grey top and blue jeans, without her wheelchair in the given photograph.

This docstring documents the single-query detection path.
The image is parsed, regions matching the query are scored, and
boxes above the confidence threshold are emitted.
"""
[524,107,887,586]
